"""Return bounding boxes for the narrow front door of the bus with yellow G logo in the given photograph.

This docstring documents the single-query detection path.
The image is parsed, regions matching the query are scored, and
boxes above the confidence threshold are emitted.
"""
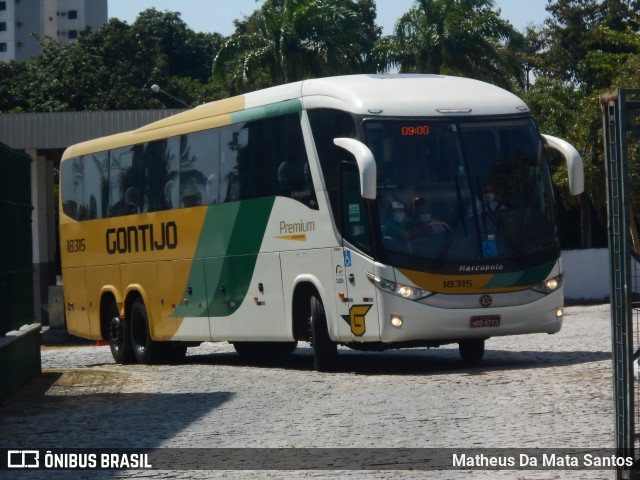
[340,164,380,342]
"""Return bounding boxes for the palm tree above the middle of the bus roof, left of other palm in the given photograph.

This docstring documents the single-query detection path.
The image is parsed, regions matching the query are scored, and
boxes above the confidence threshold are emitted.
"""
[213,0,380,94]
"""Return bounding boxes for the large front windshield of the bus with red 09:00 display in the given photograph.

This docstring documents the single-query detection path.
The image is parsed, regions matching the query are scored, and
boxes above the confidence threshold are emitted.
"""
[363,118,558,264]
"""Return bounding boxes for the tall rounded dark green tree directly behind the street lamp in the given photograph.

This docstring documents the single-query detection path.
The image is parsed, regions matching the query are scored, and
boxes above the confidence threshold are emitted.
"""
[81,8,223,109]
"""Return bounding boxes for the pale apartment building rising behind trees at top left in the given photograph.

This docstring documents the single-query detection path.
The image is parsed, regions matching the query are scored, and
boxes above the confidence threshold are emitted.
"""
[0,0,108,62]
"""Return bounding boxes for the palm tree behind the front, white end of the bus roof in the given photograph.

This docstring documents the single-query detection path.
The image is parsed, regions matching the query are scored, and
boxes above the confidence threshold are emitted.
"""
[379,0,522,87]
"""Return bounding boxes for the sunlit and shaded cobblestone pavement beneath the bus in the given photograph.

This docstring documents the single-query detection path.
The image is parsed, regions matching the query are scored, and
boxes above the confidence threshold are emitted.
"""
[0,305,615,479]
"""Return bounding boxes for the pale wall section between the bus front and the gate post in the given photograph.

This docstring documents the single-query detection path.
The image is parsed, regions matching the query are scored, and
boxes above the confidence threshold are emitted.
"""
[562,248,609,302]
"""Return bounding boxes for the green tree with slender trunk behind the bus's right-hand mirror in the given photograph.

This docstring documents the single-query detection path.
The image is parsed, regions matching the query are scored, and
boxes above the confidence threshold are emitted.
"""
[534,0,640,248]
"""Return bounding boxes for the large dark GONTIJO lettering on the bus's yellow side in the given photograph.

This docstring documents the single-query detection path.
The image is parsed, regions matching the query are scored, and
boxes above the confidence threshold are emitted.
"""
[106,222,178,255]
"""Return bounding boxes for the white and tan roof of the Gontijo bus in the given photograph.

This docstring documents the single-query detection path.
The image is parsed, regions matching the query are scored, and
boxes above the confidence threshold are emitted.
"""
[63,74,529,159]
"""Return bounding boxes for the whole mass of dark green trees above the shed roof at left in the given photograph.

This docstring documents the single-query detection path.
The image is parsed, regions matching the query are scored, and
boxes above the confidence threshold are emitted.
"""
[0,9,223,111]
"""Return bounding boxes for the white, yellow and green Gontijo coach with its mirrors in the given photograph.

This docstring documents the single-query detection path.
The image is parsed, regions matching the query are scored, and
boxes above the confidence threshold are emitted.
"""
[60,75,583,370]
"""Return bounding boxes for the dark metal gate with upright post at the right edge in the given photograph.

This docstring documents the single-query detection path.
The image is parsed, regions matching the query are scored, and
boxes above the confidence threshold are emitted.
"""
[600,90,640,478]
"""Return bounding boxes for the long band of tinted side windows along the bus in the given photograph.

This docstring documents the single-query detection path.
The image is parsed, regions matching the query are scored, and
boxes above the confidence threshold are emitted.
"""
[62,113,318,220]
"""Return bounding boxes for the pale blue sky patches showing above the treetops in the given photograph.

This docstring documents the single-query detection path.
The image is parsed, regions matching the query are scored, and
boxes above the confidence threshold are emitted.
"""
[108,0,547,36]
